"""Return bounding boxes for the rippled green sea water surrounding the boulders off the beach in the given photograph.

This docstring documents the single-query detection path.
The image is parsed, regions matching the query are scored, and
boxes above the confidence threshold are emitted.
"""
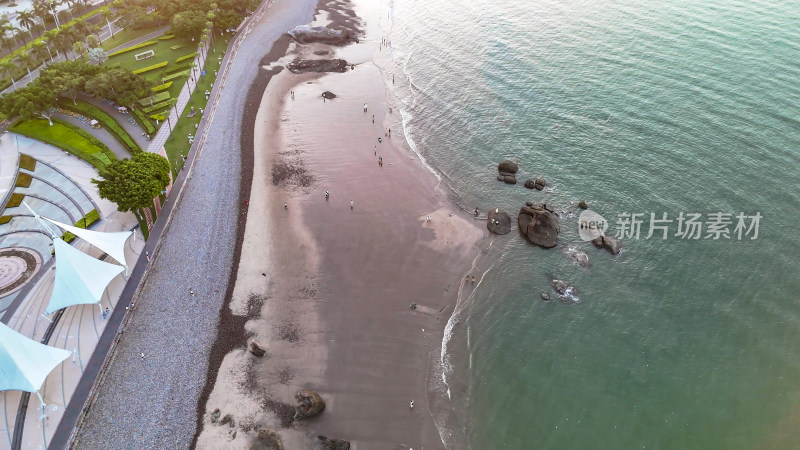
[390,0,800,449]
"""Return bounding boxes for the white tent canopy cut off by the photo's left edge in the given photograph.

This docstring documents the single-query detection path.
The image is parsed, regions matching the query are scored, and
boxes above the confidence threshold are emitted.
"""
[0,323,72,392]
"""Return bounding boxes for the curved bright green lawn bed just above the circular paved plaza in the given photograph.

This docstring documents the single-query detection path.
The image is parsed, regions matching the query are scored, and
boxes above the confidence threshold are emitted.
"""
[8,119,117,170]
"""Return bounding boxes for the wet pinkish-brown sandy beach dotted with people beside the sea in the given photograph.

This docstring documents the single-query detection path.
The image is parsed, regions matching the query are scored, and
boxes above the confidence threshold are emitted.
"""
[197,2,487,449]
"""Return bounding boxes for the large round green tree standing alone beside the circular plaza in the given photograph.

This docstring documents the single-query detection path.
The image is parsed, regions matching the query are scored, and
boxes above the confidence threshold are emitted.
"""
[92,152,170,237]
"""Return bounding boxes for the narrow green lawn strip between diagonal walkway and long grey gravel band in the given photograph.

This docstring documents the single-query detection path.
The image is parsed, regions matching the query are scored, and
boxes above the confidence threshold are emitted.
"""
[164,35,230,176]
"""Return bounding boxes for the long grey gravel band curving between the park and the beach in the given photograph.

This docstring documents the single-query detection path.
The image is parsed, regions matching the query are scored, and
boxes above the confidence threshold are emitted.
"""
[68,0,316,449]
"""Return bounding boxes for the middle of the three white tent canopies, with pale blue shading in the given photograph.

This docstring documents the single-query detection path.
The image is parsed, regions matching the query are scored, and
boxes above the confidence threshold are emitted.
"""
[45,237,123,314]
